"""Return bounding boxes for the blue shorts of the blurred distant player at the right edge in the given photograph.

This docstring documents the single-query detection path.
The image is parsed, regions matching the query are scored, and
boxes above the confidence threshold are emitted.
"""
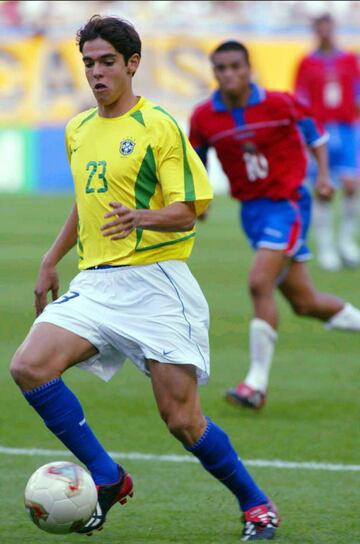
[309,123,359,182]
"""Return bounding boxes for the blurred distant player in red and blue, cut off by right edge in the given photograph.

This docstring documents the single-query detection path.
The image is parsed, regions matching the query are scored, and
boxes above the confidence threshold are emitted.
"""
[295,15,360,271]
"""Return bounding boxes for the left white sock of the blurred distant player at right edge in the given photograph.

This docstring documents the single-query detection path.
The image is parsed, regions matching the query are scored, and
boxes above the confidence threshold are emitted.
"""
[313,198,335,253]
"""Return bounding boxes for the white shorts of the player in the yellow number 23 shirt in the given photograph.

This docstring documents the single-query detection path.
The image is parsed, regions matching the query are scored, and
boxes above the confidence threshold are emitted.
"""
[34,261,210,384]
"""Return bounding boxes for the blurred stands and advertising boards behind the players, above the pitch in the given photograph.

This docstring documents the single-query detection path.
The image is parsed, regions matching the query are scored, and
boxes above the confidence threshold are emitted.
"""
[0,0,360,192]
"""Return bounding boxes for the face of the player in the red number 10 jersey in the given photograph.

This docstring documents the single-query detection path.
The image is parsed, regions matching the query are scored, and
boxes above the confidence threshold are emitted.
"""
[212,51,251,94]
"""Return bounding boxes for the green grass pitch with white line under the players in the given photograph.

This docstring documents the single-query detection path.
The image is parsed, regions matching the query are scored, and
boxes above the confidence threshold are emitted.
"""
[0,195,360,544]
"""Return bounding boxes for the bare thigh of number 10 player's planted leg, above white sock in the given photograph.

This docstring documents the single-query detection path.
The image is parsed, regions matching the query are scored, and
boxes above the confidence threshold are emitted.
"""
[249,248,289,293]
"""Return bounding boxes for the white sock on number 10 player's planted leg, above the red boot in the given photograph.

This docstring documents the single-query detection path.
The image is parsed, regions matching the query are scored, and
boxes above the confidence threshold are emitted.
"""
[244,318,277,393]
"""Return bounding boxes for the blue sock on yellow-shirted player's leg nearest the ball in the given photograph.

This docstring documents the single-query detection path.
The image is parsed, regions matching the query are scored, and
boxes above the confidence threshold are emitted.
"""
[23,378,121,484]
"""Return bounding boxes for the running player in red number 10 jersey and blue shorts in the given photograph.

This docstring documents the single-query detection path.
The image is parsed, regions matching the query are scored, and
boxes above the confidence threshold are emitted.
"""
[190,41,360,408]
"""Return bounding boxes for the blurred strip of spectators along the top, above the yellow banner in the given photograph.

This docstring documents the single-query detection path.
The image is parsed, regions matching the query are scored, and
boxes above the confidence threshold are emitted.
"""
[0,0,360,34]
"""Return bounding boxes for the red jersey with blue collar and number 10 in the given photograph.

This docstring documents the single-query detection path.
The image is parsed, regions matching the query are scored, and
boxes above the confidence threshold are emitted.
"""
[190,84,327,200]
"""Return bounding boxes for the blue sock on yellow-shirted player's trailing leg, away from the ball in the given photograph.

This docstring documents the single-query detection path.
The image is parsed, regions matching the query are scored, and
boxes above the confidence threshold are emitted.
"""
[185,418,268,511]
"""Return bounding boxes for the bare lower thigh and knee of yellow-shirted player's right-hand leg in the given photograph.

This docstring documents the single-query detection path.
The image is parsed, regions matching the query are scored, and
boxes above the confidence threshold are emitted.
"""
[147,359,203,427]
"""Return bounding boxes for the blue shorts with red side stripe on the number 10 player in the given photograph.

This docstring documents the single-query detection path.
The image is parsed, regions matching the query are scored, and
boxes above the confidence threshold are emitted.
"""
[240,186,311,261]
